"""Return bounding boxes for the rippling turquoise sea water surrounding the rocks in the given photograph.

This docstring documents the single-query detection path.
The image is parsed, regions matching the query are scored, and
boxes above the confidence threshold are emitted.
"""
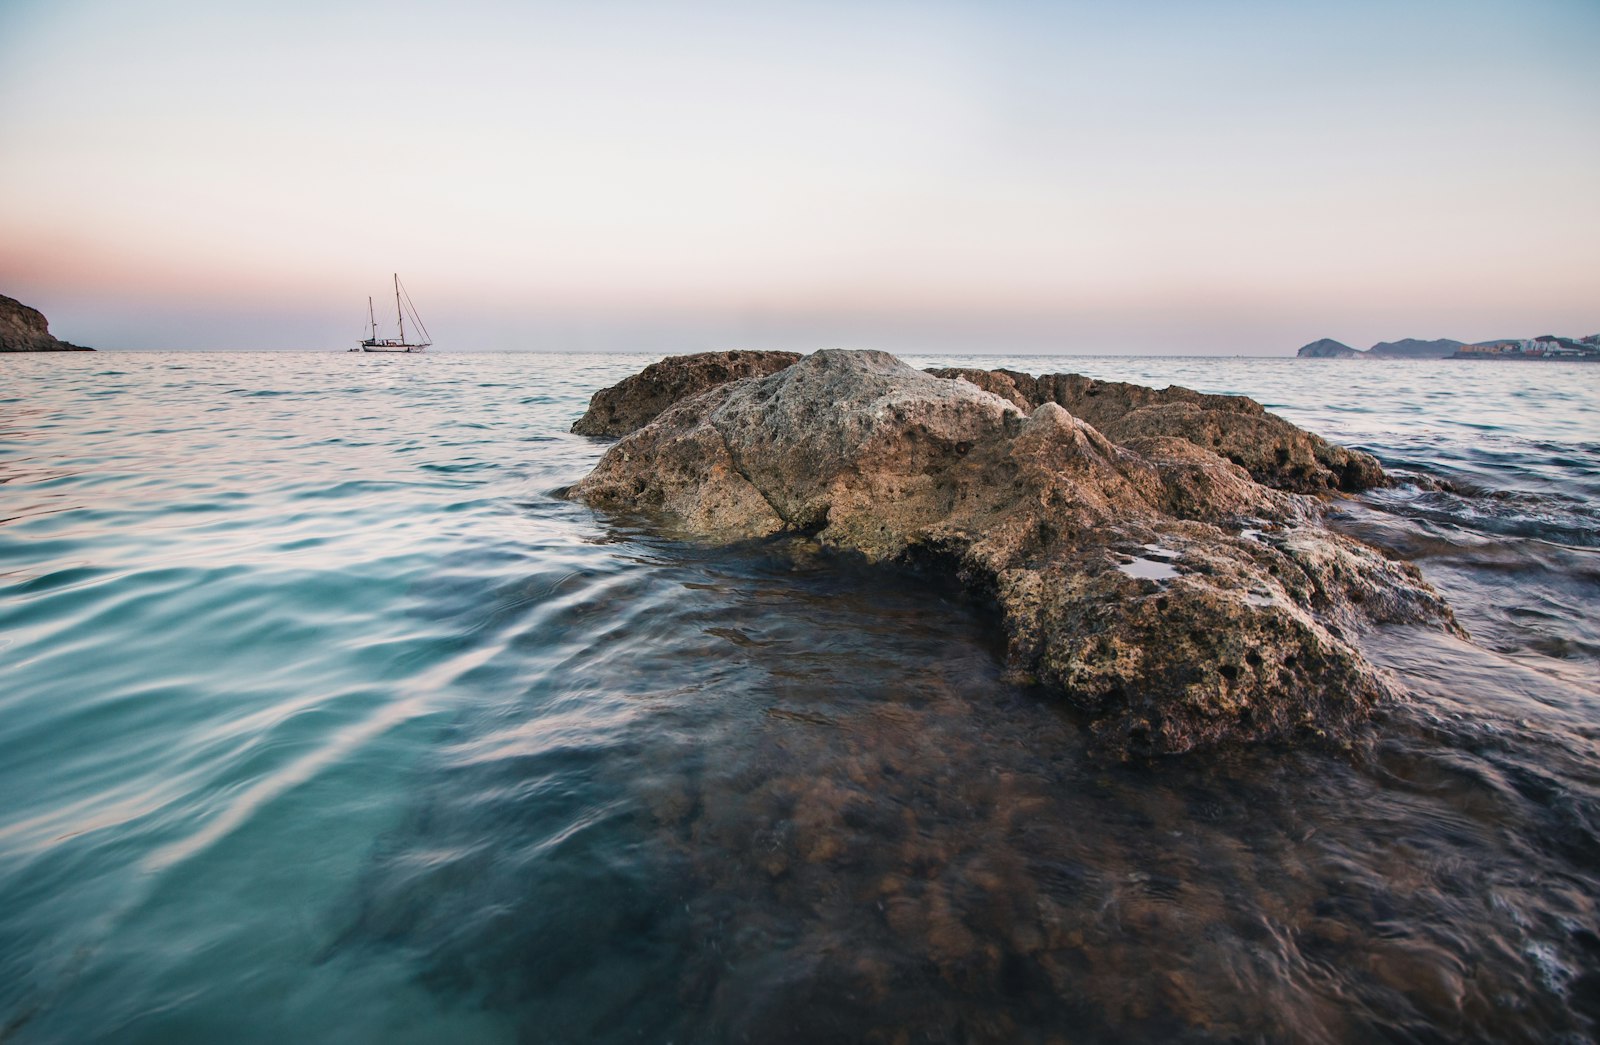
[0,350,1600,1045]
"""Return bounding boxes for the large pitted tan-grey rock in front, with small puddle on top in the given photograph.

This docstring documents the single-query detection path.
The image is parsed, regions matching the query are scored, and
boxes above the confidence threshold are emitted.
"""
[568,352,1454,754]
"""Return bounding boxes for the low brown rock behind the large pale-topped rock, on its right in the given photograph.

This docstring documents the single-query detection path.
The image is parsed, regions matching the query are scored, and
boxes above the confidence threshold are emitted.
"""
[928,370,1389,493]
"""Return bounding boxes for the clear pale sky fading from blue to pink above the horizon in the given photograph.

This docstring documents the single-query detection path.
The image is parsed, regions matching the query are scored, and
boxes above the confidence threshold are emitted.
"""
[0,0,1600,355]
